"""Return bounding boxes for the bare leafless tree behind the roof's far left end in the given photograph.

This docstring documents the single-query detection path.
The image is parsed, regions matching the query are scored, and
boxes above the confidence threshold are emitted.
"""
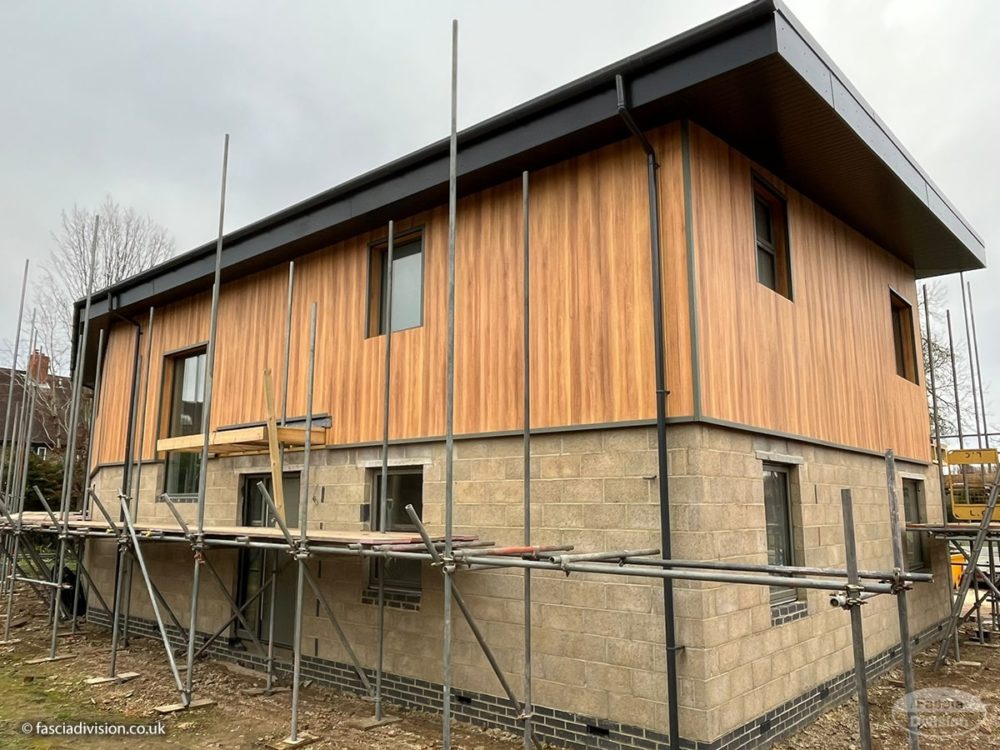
[33,196,174,374]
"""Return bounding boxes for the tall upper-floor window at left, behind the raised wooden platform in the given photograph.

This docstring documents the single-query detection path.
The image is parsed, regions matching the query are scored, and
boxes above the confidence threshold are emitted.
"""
[164,350,205,497]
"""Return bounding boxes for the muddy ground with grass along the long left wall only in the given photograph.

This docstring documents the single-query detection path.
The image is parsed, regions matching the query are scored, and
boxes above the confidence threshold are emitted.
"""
[0,591,521,750]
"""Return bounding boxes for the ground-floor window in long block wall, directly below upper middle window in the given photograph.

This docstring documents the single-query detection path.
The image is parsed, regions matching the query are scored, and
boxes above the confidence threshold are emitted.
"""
[371,466,424,592]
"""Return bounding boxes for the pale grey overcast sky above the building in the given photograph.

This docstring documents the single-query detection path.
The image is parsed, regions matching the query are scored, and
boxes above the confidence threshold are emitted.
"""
[0,0,1000,424]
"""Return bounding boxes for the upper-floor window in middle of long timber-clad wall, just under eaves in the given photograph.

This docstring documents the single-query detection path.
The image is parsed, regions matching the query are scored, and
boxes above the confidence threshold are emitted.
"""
[368,234,424,336]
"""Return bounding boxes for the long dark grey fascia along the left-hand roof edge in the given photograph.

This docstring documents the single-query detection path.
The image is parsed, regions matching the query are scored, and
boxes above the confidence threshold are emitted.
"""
[80,13,775,324]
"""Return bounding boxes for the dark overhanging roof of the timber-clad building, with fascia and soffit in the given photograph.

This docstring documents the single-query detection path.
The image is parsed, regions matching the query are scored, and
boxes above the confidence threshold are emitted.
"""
[76,0,986,378]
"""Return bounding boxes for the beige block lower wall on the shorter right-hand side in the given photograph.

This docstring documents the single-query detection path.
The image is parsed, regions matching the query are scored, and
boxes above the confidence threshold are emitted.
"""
[671,426,950,738]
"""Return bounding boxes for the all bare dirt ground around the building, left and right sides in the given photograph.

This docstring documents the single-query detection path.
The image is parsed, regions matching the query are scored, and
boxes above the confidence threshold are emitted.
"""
[0,592,1000,750]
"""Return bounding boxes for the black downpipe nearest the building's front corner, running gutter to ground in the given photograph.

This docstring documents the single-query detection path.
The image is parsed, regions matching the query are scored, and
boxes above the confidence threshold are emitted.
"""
[615,75,680,750]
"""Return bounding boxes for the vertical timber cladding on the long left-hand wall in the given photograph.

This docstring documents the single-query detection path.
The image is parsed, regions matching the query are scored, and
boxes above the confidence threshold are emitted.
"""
[88,124,692,463]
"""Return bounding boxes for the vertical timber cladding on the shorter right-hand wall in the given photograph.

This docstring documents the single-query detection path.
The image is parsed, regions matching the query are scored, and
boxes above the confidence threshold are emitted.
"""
[691,124,930,460]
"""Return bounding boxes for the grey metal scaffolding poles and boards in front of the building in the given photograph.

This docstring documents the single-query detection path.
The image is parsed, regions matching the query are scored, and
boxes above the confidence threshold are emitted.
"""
[0,22,944,750]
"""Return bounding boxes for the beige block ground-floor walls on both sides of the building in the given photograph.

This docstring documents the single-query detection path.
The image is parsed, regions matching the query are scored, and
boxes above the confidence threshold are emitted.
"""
[82,425,948,742]
